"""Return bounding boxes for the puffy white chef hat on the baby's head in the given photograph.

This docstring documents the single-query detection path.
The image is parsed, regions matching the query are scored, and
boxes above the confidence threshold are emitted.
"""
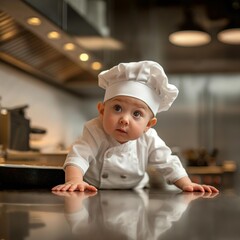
[98,61,178,115]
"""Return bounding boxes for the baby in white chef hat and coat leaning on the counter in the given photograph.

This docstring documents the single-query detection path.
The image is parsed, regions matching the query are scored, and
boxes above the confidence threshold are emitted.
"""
[52,61,218,193]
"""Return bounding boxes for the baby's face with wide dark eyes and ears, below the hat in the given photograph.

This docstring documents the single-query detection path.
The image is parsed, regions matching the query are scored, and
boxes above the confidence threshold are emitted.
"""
[99,96,156,143]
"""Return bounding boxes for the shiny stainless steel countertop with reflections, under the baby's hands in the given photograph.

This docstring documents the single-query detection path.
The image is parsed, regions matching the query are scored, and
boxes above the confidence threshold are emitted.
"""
[0,189,240,240]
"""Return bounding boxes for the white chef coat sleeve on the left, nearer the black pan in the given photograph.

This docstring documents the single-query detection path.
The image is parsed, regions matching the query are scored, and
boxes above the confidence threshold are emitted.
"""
[63,124,99,175]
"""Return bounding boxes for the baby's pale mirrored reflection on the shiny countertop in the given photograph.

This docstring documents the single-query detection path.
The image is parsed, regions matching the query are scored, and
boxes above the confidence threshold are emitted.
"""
[52,190,210,240]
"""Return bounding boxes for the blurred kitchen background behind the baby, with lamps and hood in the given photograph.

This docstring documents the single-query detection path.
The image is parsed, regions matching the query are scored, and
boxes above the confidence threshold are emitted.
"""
[0,0,240,189]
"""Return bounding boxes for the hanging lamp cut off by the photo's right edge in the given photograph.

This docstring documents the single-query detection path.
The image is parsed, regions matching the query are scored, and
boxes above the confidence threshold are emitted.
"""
[217,1,240,45]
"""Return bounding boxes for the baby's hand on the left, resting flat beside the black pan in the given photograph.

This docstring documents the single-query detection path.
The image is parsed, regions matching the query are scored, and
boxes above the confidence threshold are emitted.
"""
[52,180,97,192]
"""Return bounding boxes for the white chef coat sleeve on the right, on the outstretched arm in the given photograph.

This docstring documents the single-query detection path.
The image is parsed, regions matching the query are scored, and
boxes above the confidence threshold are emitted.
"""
[147,129,187,184]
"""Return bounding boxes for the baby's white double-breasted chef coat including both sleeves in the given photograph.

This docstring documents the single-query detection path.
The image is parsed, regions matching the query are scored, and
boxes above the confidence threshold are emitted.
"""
[63,118,187,189]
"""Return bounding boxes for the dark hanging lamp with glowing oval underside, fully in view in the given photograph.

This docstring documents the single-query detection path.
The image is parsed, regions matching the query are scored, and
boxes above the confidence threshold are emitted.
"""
[169,8,211,47]
